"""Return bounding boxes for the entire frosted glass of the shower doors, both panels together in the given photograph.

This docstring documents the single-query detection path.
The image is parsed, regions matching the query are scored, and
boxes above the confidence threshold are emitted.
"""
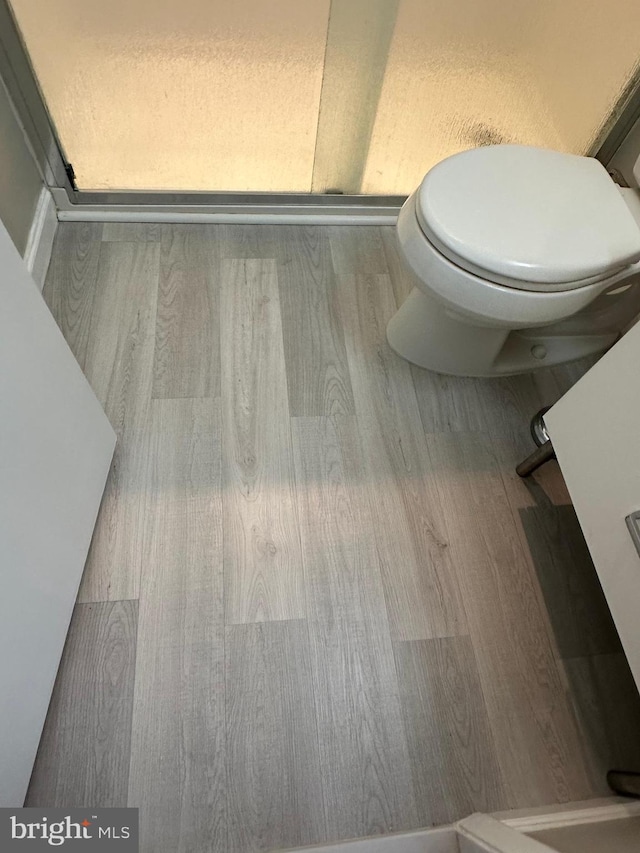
[5,0,640,194]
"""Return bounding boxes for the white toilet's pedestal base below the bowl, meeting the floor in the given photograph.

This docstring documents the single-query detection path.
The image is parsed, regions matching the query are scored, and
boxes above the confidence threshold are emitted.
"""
[387,287,619,377]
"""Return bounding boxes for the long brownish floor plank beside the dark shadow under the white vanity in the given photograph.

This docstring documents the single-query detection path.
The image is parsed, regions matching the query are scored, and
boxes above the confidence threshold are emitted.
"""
[429,433,591,807]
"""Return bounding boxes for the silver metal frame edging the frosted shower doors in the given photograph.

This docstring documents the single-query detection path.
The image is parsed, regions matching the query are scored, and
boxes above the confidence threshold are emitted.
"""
[0,0,640,216]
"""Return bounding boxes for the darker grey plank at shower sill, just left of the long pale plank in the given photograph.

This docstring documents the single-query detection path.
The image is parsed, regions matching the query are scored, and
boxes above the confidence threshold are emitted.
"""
[153,225,220,397]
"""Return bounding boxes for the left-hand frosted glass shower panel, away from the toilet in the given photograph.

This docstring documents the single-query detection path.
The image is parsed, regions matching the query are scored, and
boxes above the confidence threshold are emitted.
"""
[12,0,330,191]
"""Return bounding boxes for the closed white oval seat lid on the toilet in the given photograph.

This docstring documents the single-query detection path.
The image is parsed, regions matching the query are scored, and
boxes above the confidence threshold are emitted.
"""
[417,145,640,283]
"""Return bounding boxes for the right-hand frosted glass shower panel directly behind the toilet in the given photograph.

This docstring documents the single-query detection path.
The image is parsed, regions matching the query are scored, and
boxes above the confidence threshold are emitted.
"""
[358,0,640,193]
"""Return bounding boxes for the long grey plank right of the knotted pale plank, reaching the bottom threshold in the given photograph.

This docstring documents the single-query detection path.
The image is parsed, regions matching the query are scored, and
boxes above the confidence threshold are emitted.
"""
[293,417,419,839]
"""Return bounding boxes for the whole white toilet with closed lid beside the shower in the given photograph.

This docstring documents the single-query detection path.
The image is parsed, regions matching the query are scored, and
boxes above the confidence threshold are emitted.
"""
[387,145,640,376]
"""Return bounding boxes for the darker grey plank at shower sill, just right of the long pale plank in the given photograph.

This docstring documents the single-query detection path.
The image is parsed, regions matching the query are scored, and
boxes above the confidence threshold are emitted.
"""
[278,226,354,416]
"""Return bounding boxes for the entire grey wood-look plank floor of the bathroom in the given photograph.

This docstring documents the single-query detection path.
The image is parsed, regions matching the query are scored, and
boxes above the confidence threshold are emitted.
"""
[27,223,640,853]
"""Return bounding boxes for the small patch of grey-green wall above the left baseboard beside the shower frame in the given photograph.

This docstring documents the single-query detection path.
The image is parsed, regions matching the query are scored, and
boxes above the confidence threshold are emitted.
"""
[0,81,43,255]
